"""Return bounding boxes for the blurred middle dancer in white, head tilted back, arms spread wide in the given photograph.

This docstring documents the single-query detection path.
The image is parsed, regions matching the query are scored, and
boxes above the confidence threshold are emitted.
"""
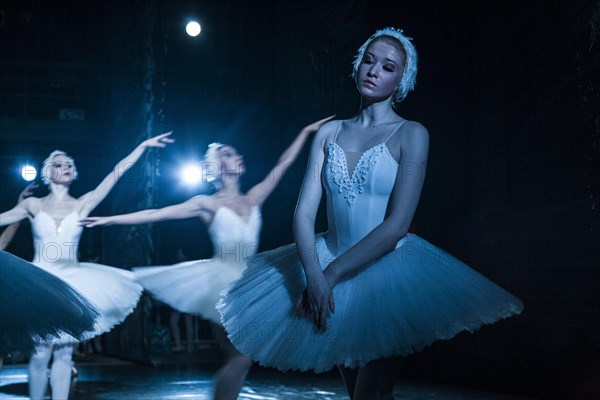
[82,117,332,400]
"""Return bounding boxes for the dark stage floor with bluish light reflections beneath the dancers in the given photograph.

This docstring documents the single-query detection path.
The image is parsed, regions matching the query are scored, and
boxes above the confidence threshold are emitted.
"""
[0,356,532,400]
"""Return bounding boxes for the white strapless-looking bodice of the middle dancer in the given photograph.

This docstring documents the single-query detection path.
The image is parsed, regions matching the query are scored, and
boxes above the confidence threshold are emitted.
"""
[208,206,262,264]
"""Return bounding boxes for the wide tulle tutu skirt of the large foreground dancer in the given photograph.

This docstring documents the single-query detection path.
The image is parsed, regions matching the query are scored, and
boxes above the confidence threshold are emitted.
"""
[218,234,523,372]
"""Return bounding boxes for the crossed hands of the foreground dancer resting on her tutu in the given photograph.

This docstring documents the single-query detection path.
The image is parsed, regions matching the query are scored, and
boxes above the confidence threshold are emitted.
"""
[294,275,335,331]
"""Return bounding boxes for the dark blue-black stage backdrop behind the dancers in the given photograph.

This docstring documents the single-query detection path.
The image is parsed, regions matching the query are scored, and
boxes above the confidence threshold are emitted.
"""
[0,0,600,399]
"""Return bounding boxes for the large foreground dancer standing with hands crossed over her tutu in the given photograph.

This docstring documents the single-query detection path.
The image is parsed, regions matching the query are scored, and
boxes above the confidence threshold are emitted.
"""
[218,28,523,400]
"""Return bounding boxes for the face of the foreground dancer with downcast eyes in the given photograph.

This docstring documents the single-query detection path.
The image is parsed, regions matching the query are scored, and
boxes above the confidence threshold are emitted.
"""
[356,39,405,101]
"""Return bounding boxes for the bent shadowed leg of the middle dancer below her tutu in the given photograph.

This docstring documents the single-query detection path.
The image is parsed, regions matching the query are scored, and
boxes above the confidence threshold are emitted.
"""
[212,324,252,400]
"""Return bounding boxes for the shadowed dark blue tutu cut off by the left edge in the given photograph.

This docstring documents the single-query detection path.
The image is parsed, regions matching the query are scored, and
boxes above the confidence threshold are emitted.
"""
[0,251,98,355]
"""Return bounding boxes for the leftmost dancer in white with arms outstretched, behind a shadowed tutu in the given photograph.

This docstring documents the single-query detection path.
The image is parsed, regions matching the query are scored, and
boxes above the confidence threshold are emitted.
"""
[0,132,173,400]
